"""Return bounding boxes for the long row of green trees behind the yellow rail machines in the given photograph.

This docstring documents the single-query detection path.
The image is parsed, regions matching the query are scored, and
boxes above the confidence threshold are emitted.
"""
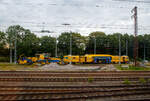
[0,25,150,60]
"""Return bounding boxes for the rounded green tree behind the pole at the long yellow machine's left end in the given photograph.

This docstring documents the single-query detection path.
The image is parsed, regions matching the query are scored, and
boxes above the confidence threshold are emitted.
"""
[58,32,86,55]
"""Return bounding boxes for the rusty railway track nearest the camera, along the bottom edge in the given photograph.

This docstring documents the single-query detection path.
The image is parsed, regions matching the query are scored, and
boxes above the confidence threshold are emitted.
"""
[0,87,150,101]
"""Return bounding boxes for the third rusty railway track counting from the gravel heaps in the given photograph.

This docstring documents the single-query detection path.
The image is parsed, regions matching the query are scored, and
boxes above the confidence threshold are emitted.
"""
[0,85,150,94]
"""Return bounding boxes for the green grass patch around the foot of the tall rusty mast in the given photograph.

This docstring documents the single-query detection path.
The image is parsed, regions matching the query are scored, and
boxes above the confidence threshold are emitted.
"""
[115,65,150,71]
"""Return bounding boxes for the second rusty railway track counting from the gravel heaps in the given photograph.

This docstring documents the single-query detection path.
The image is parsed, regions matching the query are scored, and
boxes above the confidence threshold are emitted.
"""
[0,77,150,82]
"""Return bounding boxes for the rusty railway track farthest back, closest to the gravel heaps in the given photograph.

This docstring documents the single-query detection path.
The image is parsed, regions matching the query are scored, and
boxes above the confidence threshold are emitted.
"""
[0,71,150,78]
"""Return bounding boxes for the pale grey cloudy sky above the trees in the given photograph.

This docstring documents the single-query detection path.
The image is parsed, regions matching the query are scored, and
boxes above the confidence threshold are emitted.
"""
[0,0,150,36]
